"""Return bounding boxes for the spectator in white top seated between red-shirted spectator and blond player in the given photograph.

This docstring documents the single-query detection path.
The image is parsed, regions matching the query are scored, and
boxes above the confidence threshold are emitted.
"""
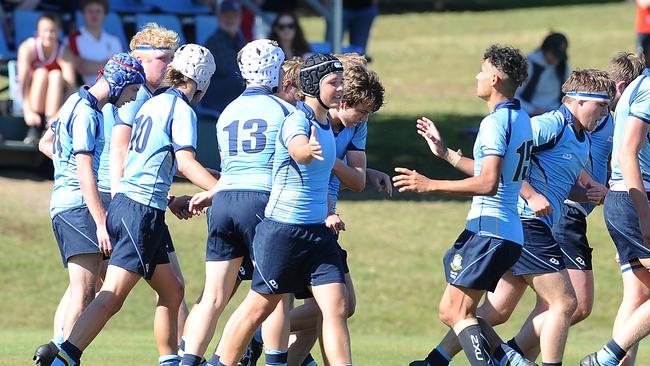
[66,0,122,86]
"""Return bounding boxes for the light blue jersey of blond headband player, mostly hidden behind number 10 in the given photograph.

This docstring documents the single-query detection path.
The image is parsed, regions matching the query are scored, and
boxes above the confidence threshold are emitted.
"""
[97,85,153,193]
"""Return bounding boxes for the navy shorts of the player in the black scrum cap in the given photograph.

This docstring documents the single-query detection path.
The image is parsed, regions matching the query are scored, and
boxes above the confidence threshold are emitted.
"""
[251,218,345,294]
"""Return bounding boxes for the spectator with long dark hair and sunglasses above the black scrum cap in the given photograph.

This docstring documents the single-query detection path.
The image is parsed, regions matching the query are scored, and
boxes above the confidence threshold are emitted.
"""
[268,13,311,59]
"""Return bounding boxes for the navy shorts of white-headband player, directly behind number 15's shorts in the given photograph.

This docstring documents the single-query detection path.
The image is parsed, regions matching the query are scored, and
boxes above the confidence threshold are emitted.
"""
[512,219,566,276]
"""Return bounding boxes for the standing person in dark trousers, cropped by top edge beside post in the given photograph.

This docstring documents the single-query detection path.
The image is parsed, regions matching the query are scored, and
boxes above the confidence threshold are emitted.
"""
[323,0,379,54]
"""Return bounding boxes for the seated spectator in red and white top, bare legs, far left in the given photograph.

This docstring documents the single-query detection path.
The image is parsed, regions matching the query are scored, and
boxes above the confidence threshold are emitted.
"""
[17,14,75,144]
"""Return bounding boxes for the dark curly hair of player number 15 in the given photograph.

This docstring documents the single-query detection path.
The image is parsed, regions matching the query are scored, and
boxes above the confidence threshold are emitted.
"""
[483,44,528,93]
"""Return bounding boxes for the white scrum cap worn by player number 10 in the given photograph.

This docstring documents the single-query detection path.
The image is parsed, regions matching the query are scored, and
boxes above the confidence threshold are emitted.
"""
[172,43,217,93]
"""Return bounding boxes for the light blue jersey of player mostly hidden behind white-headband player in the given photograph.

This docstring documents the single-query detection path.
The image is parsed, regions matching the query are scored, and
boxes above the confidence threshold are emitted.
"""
[565,113,614,216]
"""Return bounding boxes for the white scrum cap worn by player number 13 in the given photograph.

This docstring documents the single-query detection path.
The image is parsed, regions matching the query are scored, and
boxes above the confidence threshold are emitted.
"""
[239,39,284,89]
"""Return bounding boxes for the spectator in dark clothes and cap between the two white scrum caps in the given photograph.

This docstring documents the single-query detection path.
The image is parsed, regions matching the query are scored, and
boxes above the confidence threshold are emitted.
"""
[201,1,246,112]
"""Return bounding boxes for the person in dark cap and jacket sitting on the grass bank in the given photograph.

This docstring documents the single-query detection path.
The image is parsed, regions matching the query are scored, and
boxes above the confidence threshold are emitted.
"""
[516,32,571,117]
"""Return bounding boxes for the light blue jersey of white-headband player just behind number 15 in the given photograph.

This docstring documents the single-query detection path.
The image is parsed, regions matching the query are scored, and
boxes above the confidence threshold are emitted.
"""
[519,105,589,228]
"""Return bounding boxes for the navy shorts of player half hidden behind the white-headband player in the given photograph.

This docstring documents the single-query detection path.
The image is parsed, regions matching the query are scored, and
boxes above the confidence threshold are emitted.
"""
[553,204,593,271]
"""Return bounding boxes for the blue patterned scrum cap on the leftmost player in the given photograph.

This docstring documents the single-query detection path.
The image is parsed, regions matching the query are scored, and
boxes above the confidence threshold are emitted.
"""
[99,53,146,103]
